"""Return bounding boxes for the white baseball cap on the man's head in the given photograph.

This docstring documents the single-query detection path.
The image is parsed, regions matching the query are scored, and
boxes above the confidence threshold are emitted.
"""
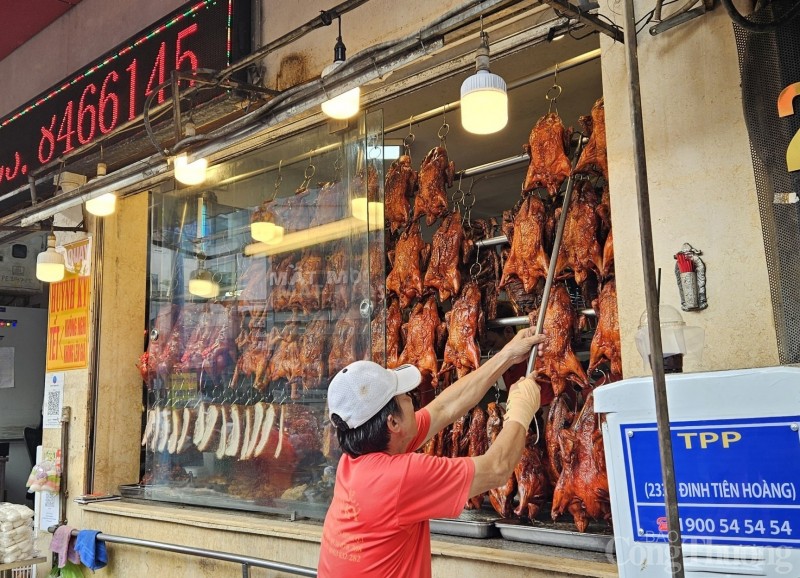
[328,361,422,429]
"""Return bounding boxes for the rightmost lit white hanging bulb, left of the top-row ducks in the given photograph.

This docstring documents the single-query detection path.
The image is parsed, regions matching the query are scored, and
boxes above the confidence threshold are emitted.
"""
[461,28,508,134]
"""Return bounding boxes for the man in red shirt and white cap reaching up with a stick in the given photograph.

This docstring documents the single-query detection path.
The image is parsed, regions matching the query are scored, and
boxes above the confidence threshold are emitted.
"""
[318,328,544,578]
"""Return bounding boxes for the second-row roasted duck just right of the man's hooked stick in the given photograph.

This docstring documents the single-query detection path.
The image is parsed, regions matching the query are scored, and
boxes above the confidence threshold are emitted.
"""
[555,181,603,285]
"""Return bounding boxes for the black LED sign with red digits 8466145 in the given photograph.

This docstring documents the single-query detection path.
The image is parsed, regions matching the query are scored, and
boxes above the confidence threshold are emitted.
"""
[0,0,250,193]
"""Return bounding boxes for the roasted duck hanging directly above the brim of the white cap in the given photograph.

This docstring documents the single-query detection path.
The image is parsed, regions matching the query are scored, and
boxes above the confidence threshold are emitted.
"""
[398,296,445,387]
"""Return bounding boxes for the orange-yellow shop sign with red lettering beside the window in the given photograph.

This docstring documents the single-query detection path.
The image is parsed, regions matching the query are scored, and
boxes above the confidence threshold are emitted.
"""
[46,237,92,372]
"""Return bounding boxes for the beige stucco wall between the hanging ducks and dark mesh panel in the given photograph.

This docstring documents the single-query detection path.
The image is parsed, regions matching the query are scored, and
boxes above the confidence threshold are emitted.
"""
[601,2,778,377]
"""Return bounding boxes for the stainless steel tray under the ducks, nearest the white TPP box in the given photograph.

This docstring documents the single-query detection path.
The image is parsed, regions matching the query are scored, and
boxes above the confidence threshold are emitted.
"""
[496,519,614,553]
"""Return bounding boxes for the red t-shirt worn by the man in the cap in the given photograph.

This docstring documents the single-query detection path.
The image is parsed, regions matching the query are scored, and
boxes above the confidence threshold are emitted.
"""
[318,409,475,578]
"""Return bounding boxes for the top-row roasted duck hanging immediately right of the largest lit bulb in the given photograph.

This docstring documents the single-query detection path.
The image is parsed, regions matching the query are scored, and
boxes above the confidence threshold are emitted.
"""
[522,112,572,196]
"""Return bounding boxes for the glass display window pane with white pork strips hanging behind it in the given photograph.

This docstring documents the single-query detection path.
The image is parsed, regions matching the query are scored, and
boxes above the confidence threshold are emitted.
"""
[135,111,386,518]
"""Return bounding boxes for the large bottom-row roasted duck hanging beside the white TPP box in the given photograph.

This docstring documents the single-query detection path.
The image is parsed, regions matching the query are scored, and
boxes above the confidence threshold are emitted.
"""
[551,393,611,532]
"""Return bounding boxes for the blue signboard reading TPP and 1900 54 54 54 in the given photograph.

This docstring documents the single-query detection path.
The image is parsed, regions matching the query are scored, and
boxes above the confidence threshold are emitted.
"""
[620,416,800,548]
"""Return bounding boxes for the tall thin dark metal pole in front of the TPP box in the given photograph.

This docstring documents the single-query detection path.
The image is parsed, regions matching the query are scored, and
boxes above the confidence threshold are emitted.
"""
[625,0,684,578]
